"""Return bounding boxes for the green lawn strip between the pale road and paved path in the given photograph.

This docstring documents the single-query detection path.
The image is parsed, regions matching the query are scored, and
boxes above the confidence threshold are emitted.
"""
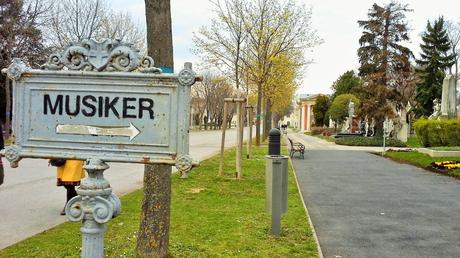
[0,147,317,258]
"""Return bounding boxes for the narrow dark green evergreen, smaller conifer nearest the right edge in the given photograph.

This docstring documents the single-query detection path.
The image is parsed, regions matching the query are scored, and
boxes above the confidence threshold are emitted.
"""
[416,17,455,115]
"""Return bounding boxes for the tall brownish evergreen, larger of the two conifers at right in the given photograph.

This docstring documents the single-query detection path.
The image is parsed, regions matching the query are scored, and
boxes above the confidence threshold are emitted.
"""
[358,2,413,134]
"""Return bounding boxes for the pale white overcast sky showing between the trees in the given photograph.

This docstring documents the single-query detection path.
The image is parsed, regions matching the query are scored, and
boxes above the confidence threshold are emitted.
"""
[109,0,460,93]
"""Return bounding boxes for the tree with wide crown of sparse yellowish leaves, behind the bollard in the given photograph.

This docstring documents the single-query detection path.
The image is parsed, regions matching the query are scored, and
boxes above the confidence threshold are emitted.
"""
[194,0,320,145]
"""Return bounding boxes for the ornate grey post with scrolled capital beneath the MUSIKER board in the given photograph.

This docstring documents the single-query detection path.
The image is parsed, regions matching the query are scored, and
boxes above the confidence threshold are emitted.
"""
[65,159,121,258]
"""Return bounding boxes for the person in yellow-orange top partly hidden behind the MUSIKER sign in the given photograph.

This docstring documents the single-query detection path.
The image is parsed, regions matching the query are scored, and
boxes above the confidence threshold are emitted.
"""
[54,160,85,215]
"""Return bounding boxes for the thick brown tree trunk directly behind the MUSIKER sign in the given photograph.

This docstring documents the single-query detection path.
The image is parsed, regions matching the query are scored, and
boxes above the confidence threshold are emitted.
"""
[137,0,174,257]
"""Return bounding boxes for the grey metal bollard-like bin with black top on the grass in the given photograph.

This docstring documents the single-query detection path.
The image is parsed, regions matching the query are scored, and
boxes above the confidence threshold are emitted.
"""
[265,128,288,236]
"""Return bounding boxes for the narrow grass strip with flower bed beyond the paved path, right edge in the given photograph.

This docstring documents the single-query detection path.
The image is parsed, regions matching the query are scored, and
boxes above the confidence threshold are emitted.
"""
[385,151,460,178]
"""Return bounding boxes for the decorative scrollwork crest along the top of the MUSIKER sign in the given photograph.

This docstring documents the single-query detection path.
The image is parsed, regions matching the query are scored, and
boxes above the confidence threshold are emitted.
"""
[42,39,161,73]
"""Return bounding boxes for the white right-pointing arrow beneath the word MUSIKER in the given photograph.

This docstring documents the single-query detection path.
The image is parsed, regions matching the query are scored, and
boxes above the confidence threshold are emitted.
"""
[56,123,140,141]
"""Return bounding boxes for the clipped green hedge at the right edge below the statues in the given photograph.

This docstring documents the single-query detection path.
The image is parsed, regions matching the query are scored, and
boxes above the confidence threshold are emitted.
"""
[414,119,460,147]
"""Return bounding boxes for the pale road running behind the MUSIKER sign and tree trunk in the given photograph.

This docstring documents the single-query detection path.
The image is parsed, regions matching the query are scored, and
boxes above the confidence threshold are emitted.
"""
[0,128,255,249]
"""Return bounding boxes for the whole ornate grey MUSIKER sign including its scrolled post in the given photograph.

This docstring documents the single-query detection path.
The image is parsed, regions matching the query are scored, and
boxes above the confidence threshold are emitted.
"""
[2,40,200,257]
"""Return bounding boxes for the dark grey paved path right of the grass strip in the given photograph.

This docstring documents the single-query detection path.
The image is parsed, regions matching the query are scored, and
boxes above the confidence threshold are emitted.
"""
[290,134,460,258]
